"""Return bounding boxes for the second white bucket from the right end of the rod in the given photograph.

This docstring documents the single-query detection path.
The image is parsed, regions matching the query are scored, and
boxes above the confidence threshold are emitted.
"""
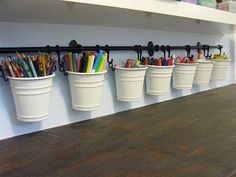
[193,61,214,85]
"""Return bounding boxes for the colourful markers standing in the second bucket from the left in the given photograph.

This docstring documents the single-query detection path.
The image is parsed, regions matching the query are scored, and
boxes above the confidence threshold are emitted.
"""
[63,50,107,73]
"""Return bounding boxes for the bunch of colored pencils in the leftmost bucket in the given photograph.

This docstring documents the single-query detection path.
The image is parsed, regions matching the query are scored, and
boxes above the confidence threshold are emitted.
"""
[2,53,57,78]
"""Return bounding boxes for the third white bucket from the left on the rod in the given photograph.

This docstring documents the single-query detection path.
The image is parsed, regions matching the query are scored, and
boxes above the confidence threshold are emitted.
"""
[115,66,147,102]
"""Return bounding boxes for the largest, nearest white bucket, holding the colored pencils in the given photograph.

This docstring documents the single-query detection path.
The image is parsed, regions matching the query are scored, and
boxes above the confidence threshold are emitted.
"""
[9,74,55,122]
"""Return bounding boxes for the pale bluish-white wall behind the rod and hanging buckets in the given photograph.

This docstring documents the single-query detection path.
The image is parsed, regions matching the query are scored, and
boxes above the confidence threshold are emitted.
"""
[0,22,233,139]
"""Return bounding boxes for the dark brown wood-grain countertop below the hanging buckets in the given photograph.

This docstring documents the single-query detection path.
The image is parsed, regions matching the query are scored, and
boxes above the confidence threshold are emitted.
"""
[0,85,236,177]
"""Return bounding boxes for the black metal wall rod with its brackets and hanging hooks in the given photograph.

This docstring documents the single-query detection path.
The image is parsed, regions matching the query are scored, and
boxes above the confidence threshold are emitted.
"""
[0,40,223,78]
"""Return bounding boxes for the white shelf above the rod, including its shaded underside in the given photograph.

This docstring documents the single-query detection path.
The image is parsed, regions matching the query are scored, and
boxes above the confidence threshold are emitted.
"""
[0,0,236,34]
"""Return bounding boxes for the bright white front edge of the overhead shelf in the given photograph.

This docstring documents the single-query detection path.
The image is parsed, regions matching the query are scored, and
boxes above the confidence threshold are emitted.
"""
[63,0,236,25]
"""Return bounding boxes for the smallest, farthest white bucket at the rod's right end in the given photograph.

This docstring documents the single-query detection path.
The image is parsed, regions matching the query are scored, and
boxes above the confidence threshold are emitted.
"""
[211,59,230,81]
